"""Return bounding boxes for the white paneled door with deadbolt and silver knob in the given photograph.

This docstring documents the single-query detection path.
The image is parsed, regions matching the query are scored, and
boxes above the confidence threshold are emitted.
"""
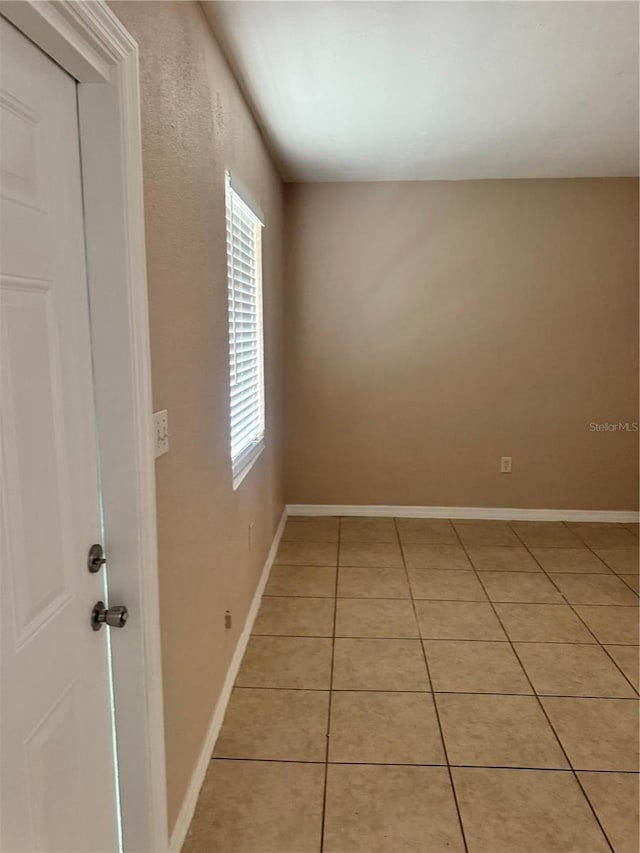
[0,19,119,853]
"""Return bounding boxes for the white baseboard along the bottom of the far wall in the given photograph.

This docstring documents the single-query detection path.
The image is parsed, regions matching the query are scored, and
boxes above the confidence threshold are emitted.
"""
[287,504,640,523]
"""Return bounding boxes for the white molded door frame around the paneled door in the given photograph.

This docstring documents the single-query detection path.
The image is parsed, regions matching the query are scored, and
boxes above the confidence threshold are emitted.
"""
[0,0,168,853]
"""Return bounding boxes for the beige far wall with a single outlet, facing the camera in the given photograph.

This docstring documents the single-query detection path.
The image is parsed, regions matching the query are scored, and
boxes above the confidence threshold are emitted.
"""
[285,179,638,510]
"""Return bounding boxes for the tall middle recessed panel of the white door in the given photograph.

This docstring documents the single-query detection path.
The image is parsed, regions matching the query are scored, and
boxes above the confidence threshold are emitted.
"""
[0,277,73,647]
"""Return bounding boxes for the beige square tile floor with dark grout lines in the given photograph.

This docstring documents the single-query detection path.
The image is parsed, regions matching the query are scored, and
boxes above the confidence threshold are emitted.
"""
[184,518,638,853]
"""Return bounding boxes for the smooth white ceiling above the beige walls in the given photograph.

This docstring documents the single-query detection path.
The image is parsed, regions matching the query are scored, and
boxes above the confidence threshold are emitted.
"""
[203,0,638,181]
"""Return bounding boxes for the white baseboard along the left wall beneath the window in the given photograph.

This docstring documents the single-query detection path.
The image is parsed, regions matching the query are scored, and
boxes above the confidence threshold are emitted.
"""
[169,509,287,853]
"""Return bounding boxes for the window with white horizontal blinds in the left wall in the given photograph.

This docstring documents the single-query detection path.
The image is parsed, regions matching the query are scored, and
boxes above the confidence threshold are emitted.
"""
[226,175,264,488]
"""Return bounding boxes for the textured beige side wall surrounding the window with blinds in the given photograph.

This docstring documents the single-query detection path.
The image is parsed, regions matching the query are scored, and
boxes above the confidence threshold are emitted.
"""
[112,2,283,828]
